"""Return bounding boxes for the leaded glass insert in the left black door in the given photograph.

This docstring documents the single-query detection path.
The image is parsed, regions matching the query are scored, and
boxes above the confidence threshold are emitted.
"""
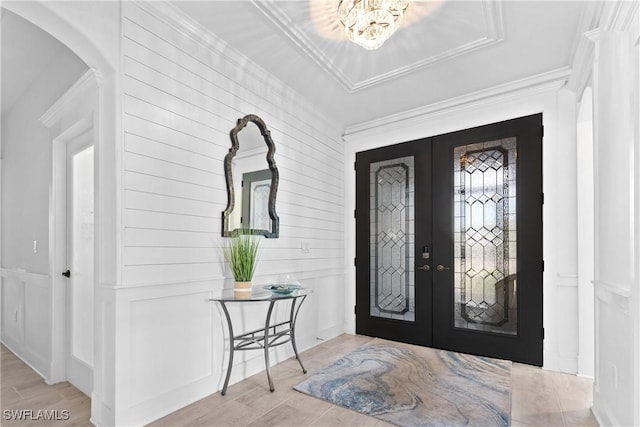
[369,157,415,322]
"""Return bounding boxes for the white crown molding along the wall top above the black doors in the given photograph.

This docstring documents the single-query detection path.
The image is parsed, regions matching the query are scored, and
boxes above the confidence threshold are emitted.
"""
[342,67,571,142]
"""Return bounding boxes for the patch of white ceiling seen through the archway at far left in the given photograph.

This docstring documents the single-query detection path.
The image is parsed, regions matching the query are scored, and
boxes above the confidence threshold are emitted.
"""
[0,9,66,114]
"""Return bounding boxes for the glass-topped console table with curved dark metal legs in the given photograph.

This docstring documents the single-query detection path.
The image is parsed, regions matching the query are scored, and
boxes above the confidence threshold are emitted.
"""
[209,287,310,396]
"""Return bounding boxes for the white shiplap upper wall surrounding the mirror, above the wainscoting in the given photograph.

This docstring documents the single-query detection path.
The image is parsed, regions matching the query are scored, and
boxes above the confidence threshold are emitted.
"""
[123,4,344,283]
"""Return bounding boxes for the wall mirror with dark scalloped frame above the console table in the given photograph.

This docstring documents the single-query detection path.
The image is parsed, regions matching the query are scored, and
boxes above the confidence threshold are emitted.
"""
[222,114,279,237]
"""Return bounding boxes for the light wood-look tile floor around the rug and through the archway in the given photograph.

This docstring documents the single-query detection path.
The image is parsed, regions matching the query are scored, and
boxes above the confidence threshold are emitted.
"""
[0,335,598,427]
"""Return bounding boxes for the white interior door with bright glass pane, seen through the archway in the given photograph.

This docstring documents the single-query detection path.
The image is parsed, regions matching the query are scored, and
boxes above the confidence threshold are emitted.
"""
[65,129,94,396]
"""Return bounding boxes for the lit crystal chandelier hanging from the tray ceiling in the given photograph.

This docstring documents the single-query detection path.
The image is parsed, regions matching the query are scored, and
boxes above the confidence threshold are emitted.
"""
[338,0,409,50]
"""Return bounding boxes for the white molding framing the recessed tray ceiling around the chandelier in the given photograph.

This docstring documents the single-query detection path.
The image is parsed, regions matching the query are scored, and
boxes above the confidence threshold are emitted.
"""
[252,0,505,93]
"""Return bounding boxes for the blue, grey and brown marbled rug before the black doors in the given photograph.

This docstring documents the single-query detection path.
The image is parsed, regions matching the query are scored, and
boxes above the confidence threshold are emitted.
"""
[294,339,511,427]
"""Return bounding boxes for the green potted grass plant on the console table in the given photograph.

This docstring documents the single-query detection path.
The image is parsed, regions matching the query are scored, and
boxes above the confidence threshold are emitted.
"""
[222,230,260,292]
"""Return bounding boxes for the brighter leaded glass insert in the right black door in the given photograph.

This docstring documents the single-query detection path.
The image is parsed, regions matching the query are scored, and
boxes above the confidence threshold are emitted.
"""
[453,138,518,335]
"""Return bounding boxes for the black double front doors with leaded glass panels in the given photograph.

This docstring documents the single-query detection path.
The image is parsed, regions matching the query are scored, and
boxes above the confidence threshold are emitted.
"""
[356,114,543,366]
